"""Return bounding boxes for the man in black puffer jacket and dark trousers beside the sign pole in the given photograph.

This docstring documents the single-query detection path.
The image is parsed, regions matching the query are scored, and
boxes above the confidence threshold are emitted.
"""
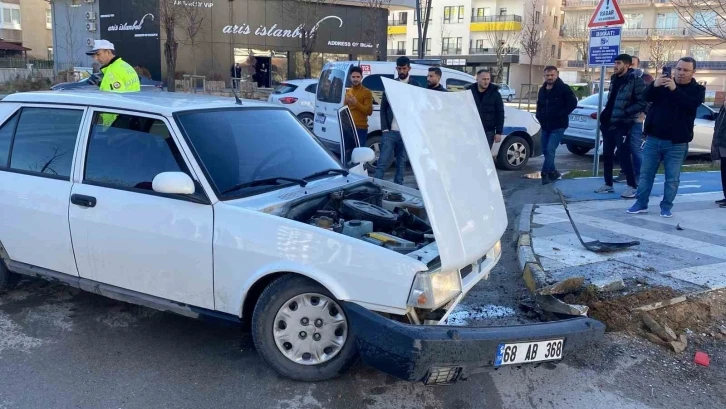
[595,54,648,198]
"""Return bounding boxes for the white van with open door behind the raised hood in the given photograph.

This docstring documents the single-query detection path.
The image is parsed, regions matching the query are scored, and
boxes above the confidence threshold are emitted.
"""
[313,61,542,170]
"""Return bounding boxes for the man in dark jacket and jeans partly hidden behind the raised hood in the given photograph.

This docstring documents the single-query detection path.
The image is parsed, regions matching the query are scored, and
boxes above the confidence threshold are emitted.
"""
[373,57,421,185]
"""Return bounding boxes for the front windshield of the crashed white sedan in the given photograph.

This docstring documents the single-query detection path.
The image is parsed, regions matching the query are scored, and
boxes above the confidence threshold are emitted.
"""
[175,108,343,199]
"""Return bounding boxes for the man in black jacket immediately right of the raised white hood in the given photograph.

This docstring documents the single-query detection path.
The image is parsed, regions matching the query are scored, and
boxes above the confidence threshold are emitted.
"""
[471,69,504,149]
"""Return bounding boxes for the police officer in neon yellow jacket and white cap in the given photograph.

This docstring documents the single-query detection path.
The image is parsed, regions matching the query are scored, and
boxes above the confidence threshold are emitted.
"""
[86,40,141,92]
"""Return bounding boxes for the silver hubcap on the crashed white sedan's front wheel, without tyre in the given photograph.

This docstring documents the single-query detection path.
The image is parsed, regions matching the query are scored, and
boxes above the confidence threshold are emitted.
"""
[273,293,348,365]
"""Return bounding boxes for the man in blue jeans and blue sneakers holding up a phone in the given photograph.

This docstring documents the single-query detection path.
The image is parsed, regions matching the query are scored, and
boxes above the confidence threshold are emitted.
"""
[628,57,706,217]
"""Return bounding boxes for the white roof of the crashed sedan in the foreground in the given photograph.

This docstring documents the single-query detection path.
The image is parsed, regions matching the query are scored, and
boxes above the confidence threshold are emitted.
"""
[2,90,276,116]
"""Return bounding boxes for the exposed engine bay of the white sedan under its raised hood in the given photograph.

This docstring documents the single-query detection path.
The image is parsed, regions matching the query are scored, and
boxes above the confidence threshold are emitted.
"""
[285,183,434,254]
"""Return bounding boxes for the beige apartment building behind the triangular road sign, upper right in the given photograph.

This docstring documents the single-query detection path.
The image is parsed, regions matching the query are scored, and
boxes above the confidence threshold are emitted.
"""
[558,0,726,91]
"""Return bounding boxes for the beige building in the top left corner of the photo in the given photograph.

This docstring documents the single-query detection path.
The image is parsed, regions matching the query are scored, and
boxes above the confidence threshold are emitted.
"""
[0,0,53,59]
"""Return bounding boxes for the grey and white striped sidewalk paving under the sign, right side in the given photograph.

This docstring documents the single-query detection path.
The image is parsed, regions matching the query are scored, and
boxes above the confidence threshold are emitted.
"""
[531,191,726,293]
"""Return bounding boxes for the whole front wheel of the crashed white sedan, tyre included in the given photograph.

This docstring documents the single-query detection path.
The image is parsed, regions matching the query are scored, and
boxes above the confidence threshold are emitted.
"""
[252,275,357,382]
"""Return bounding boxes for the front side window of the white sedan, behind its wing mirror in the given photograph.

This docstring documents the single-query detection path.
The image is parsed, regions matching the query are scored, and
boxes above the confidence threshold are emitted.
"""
[83,113,191,191]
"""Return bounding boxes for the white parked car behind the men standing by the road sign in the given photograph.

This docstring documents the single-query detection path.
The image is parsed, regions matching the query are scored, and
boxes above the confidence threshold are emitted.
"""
[562,91,717,155]
